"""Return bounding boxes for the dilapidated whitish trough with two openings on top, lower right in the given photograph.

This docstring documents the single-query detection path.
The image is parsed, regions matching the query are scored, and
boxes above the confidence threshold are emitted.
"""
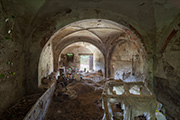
[102,81,156,120]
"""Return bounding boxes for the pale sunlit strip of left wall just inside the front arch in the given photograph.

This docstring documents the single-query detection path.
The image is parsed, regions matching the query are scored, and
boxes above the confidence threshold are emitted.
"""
[38,43,54,86]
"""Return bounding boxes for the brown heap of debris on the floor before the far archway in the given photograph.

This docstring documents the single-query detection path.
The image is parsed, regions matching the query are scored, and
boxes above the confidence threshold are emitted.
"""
[54,76,103,99]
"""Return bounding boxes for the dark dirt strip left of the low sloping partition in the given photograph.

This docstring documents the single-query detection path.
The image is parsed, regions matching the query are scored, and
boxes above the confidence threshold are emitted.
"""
[0,93,43,120]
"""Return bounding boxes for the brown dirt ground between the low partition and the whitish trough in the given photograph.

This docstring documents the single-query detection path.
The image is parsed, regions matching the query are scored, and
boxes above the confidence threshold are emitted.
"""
[46,80,103,120]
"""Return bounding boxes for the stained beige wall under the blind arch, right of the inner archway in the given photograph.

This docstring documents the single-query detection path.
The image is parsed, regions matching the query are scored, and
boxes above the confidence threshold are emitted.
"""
[110,41,143,81]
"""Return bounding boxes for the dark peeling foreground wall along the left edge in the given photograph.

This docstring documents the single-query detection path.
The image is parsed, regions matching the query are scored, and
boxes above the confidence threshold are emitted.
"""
[0,1,25,116]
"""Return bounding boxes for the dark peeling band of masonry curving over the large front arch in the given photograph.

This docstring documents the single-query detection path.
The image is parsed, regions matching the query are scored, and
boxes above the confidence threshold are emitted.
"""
[25,9,153,91]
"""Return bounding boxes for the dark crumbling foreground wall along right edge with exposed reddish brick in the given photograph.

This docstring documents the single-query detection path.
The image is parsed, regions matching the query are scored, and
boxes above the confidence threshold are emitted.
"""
[154,8,180,120]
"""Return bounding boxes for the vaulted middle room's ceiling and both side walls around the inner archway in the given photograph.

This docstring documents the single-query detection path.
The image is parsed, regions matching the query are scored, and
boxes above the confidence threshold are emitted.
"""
[38,19,149,85]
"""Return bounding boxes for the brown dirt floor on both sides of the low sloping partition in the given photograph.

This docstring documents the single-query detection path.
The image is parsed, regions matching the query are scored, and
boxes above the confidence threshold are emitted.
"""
[0,79,146,120]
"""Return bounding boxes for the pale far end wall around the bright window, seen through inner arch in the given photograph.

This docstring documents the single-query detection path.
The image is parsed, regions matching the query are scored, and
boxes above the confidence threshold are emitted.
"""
[58,42,105,74]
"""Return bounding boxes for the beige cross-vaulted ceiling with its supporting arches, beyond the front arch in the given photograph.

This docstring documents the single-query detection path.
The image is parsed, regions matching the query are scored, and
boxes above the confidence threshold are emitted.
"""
[39,19,149,86]
